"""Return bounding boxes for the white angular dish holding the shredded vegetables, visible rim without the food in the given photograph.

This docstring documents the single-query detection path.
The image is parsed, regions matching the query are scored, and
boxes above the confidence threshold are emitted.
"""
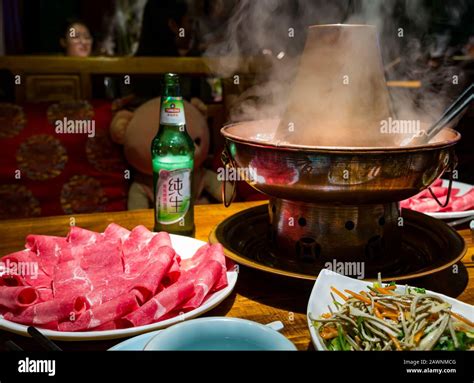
[306,269,474,351]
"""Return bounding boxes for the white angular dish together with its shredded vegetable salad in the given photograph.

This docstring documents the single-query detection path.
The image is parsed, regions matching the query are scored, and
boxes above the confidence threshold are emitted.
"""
[307,270,474,351]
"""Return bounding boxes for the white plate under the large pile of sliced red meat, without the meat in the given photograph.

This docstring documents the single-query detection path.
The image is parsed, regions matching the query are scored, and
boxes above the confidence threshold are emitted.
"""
[0,234,238,341]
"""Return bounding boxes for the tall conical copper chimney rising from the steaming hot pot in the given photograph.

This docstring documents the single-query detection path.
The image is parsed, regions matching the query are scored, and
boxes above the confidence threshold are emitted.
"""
[275,24,394,146]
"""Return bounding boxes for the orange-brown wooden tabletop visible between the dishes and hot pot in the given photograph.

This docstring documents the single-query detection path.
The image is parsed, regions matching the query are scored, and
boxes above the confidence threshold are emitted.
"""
[0,202,474,350]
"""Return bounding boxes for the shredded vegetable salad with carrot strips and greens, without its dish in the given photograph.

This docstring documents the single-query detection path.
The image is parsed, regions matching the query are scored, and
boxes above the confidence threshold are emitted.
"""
[310,282,474,351]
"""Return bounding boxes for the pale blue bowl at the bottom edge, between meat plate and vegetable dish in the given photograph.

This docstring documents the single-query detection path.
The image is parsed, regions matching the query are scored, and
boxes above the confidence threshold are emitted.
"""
[145,317,296,351]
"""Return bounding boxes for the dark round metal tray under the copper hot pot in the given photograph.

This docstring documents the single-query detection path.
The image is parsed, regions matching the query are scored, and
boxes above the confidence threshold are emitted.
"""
[210,205,466,281]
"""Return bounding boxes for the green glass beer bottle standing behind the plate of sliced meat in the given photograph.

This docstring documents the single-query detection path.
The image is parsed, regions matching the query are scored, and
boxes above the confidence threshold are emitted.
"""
[151,73,195,236]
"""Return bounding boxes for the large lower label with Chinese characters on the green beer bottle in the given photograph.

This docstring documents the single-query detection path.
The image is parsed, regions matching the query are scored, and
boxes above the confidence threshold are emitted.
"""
[155,169,191,225]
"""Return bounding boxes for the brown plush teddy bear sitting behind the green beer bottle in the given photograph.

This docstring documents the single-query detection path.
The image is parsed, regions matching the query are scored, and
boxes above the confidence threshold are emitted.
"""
[110,98,221,210]
